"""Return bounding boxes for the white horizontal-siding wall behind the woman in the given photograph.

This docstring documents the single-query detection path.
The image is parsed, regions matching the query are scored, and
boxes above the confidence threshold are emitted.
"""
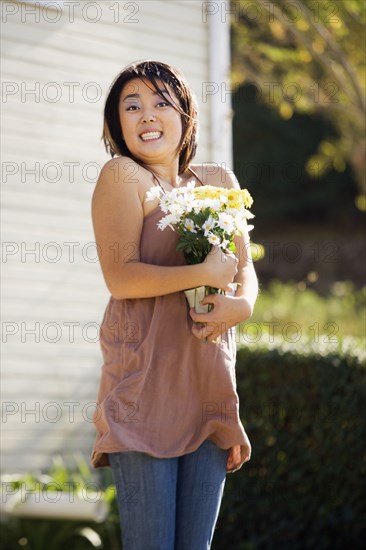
[1,0,229,472]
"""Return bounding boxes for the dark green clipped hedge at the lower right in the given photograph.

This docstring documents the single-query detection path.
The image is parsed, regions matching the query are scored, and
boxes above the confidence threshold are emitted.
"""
[212,344,366,550]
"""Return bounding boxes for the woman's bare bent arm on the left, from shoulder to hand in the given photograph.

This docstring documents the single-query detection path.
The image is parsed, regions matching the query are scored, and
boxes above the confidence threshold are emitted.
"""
[92,157,238,299]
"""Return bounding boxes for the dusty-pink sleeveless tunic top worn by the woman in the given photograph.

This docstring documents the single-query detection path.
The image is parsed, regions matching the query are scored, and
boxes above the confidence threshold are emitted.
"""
[91,170,246,468]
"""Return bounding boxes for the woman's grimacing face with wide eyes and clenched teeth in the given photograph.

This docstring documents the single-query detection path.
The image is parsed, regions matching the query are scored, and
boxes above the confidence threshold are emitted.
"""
[119,78,182,164]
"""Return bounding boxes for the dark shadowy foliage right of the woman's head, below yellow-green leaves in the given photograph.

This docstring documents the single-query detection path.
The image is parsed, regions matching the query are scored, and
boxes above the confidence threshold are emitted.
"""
[233,80,362,226]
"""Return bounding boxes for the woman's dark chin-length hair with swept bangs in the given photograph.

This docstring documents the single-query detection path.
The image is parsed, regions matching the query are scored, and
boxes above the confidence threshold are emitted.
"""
[102,61,198,174]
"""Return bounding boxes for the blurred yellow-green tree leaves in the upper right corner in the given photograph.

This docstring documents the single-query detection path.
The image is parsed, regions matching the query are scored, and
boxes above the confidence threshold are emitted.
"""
[232,0,366,197]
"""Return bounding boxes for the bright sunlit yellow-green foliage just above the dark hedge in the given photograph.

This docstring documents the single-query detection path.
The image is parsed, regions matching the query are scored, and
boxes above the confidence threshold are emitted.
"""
[243,281,366,342]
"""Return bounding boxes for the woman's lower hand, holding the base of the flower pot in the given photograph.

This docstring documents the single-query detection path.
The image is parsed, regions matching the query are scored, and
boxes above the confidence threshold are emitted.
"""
[189,294,252,342]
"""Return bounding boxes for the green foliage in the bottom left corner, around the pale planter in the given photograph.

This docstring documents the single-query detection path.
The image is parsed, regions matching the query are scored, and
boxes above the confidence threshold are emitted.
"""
[0,456,121,550]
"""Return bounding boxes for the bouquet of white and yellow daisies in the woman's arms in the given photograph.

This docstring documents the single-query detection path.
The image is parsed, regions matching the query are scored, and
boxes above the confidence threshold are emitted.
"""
[146,183,254,312]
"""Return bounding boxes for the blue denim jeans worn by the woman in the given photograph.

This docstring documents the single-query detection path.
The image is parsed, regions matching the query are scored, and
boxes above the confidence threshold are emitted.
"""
[109,440,228,550]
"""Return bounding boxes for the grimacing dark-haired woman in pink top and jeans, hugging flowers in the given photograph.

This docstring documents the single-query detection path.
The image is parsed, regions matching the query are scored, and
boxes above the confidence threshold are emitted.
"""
[92,61,257,550]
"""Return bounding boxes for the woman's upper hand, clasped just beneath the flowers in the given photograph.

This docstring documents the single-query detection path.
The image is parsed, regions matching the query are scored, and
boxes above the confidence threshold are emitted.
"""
[203,246,238,291]
